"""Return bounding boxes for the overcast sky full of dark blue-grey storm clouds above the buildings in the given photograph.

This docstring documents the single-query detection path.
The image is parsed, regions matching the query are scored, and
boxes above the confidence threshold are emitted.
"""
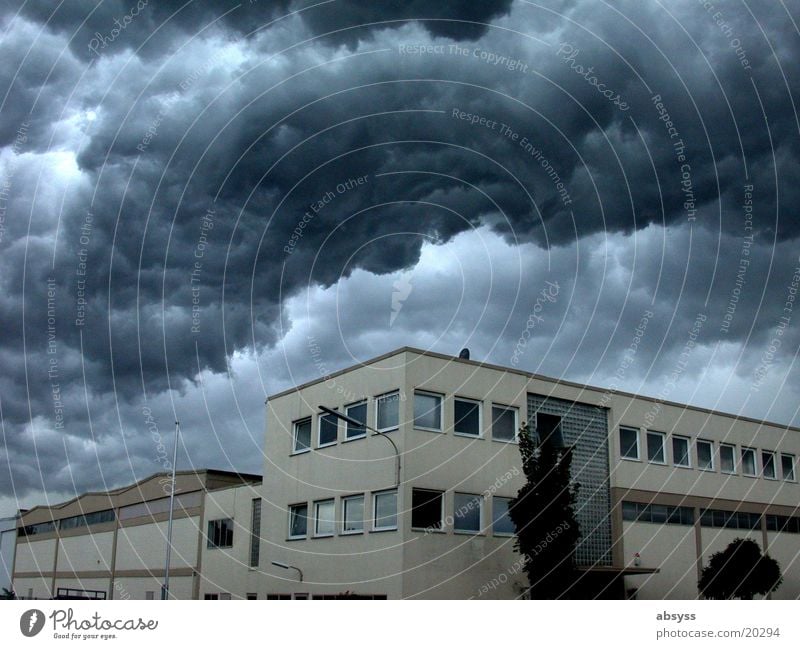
[0,0,800,515]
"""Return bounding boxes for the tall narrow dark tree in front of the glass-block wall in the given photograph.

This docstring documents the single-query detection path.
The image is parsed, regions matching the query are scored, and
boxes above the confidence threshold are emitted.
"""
[509,424,580,599]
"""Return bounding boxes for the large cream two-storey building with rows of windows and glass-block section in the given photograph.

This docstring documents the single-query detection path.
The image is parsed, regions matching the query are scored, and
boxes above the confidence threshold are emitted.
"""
[262,348,800,599]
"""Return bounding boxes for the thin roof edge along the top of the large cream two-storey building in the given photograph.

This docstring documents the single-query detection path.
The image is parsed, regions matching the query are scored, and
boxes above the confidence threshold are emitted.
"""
[267,346,800,432]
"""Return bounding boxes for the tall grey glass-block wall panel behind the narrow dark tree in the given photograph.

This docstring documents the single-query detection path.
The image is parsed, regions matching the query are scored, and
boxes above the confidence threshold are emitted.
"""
[528,393,612,566]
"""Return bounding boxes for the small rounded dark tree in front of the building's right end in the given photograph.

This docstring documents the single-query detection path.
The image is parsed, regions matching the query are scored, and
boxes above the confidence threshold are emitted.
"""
[697,539,783,599]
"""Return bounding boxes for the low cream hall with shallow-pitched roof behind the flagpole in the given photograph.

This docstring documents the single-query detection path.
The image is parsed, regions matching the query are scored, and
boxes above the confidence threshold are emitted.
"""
[13,469,261,599]
